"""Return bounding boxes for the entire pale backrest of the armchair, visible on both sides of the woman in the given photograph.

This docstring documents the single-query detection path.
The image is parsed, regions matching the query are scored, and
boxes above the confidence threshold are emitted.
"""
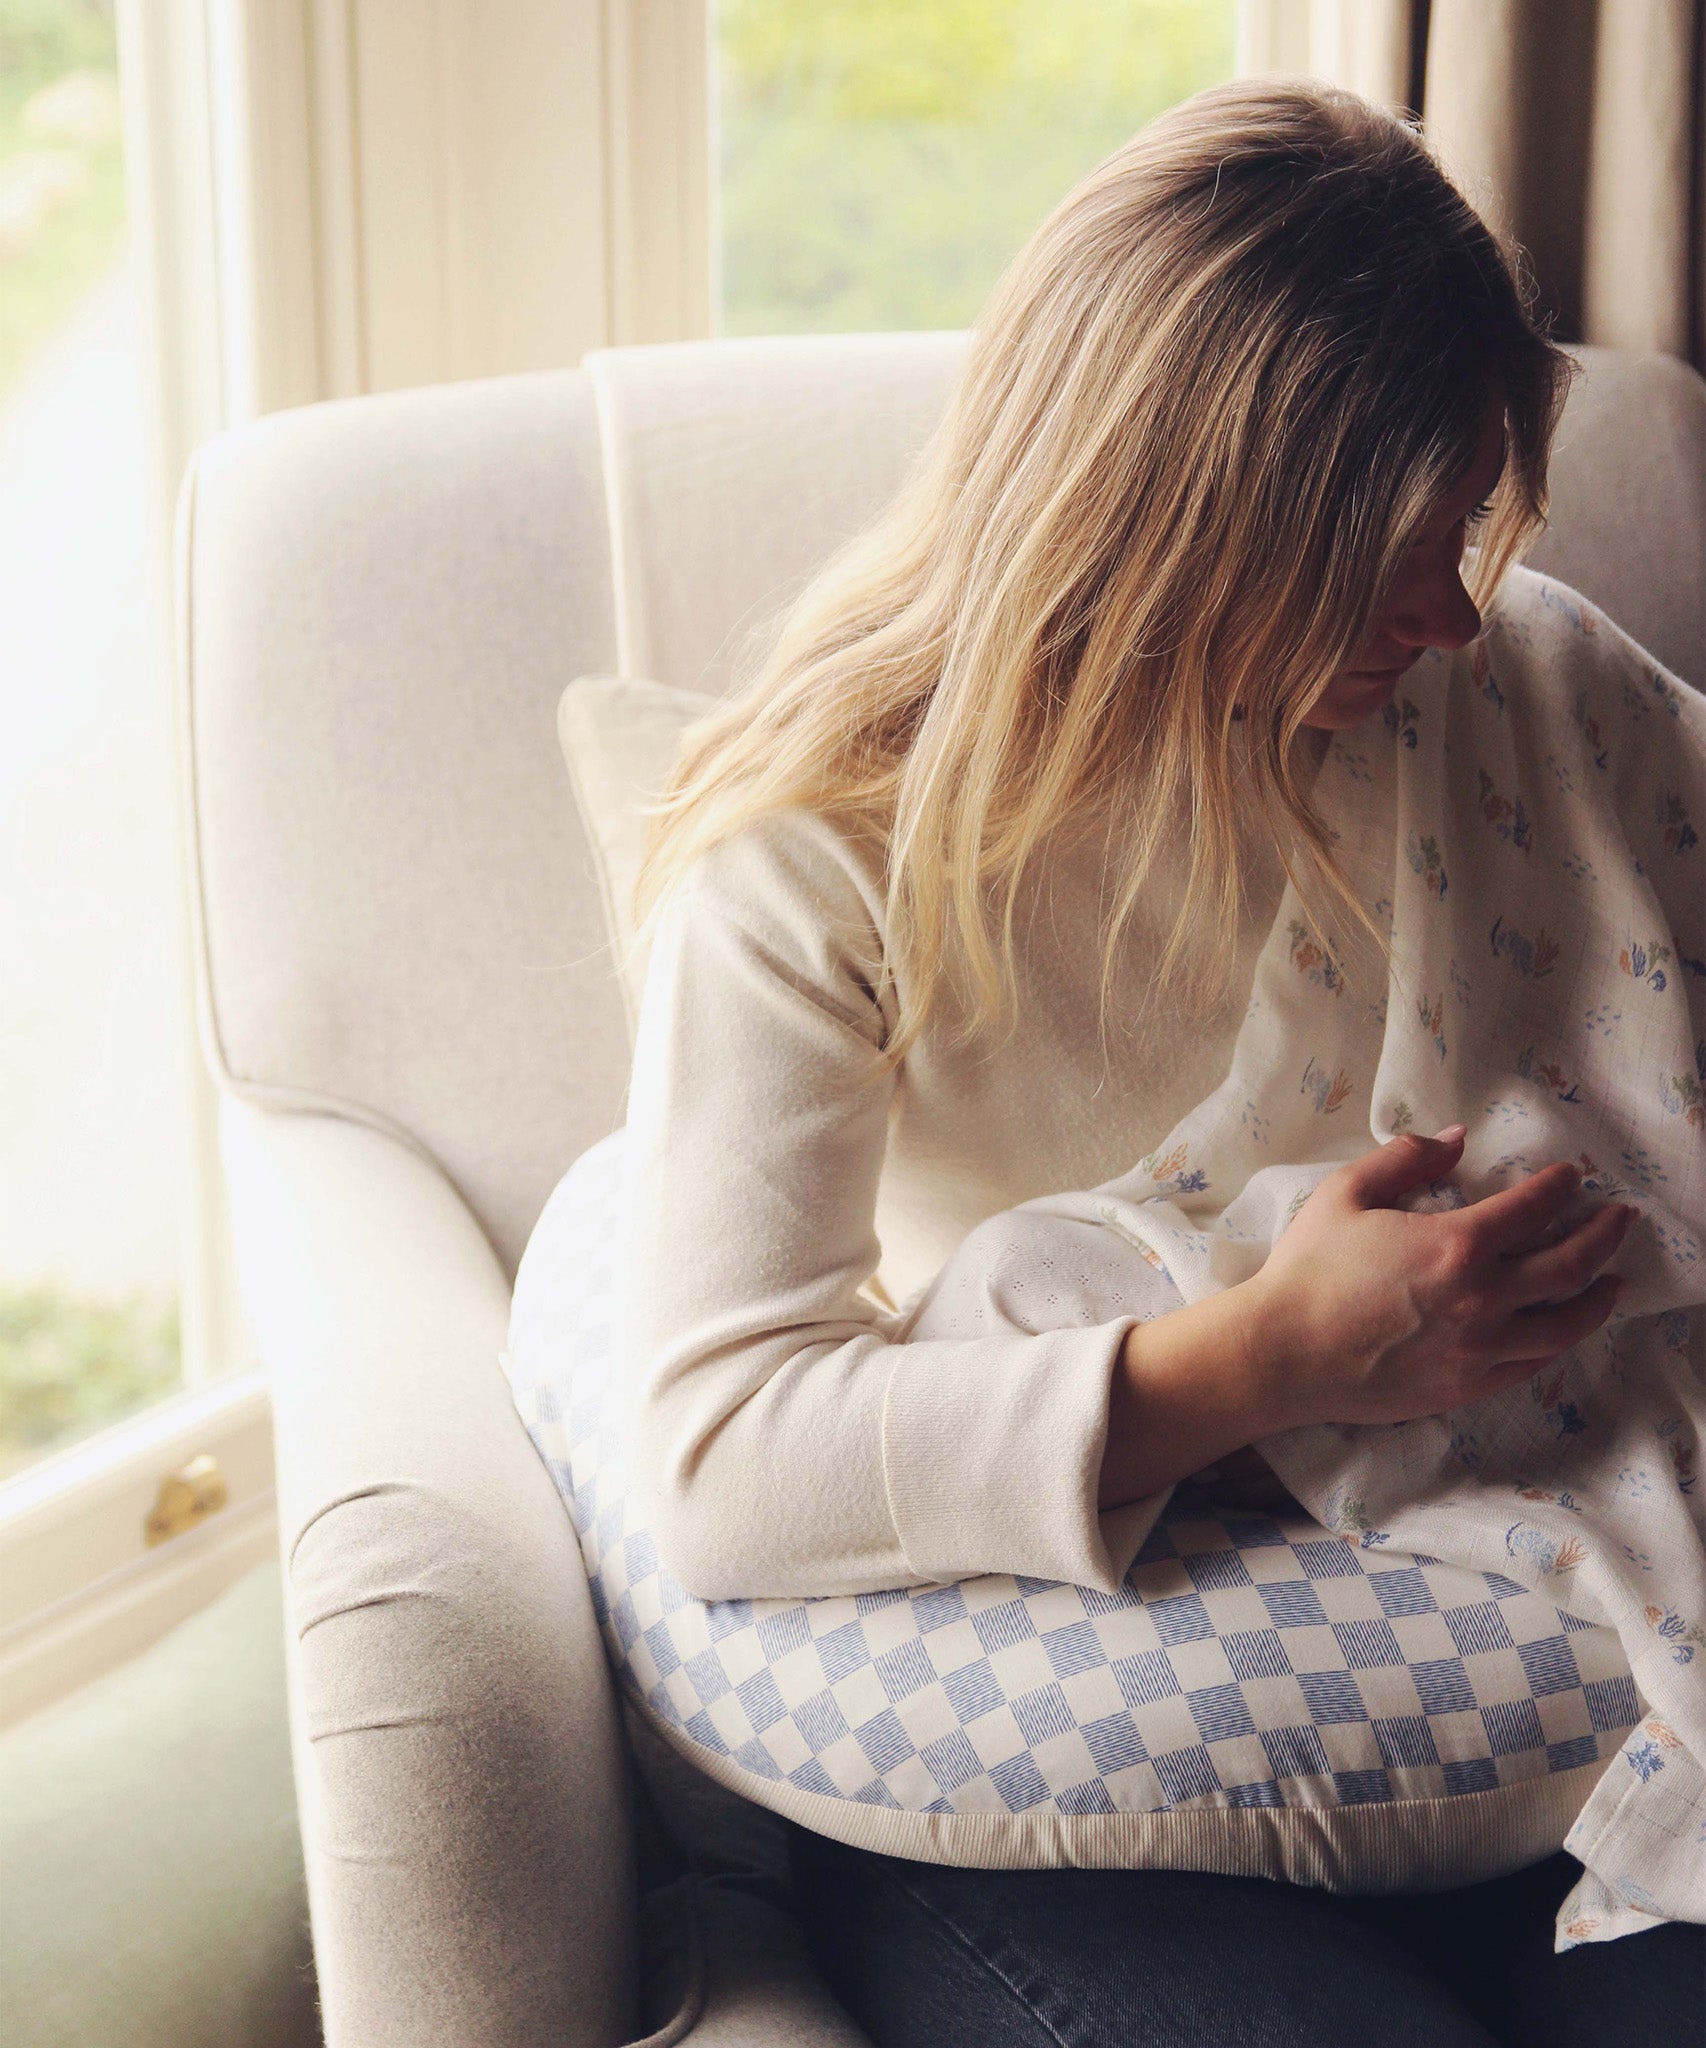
[178,334,1706,1272]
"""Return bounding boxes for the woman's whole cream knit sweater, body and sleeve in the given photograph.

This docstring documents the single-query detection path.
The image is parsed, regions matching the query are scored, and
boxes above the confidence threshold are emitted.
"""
[623,813,1282,1599]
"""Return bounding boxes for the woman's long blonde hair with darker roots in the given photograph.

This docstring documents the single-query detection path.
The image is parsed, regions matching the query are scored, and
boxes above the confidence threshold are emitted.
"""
[637,82,1571,1057]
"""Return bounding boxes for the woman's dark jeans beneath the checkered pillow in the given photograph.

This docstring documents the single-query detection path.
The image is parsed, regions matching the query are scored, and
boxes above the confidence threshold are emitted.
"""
[791,1829,1706,2048]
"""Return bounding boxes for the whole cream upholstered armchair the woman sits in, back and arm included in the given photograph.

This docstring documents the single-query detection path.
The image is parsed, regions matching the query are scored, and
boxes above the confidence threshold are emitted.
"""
[178,336,1706,2048]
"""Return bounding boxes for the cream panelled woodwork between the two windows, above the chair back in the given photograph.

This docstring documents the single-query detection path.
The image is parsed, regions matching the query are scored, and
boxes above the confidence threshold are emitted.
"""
[180,0,715,403]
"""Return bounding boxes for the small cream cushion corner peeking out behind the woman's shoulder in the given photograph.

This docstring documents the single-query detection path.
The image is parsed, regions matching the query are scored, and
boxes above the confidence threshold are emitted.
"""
[557,676,719,1034]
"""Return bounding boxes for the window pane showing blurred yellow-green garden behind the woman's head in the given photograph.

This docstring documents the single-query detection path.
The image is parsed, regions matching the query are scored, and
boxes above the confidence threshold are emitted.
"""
[715,0,1233,334]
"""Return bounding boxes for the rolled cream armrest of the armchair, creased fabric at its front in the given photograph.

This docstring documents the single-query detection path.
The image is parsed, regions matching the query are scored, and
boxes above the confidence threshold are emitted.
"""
[219,1094,635,2048]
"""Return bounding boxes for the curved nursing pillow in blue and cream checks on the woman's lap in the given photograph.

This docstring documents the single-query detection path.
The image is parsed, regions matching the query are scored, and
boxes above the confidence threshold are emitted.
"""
[504,1133,1640,1890]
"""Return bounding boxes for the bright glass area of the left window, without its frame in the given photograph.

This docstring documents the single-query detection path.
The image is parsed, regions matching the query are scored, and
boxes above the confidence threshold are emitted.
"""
[0,0,202,1477]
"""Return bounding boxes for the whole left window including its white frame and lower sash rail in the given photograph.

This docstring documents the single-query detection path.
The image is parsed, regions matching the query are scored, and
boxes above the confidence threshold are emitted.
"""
[0,0,274,1724]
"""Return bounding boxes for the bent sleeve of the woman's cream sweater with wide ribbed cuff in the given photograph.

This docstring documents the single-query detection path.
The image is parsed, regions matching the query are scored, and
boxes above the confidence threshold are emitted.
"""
[623,817,1159,1599]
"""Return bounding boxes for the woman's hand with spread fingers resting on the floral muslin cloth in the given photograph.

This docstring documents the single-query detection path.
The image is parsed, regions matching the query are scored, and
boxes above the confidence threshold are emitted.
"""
[1247,1124,1636,1427]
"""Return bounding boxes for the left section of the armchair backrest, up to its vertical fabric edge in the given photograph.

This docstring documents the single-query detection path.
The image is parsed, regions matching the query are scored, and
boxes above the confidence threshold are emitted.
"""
[178,371,629,1272]
